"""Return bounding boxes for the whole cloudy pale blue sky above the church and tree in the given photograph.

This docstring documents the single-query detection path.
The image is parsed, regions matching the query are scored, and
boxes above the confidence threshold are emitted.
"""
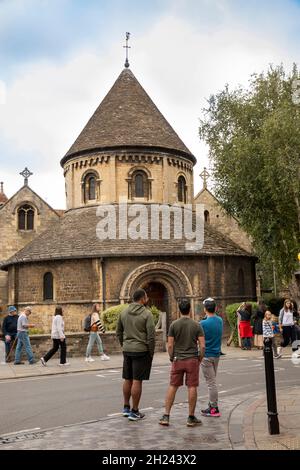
[0,0,300,209]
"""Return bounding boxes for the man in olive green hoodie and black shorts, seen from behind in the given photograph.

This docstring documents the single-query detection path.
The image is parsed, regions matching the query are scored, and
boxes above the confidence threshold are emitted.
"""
[116,289,155,421]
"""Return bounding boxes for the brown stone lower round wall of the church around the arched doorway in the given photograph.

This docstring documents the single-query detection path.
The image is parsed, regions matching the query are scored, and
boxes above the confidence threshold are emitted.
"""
[5,256,256,333]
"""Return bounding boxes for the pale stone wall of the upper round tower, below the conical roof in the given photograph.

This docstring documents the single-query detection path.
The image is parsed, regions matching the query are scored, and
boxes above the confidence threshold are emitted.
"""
[64,150,194,209]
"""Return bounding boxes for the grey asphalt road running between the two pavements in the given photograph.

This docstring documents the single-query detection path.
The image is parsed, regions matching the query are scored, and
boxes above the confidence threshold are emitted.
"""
[0,357,300,435]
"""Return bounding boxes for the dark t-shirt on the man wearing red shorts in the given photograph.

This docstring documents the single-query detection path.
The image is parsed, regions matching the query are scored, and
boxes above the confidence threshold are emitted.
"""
[169,317,204,360]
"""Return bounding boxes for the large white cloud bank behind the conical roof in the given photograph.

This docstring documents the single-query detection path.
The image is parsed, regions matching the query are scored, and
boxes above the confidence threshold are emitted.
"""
[0,1,295,207]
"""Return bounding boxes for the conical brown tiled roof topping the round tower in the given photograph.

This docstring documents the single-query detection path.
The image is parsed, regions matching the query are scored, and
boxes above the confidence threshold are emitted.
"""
[61,69,195,165]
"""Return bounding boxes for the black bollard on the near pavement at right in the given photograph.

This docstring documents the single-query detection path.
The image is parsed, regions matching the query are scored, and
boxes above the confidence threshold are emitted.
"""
[264,338,280,434]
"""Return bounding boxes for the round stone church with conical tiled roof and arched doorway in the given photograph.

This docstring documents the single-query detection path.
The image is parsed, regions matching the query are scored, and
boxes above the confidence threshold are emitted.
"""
[0,68,256,331]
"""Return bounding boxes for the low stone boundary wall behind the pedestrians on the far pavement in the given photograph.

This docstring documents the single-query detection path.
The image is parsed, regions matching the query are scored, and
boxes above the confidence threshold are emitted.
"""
[0,330,166,359]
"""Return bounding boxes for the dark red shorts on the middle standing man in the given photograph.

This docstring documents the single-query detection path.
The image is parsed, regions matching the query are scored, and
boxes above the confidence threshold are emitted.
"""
[170,357,200,387]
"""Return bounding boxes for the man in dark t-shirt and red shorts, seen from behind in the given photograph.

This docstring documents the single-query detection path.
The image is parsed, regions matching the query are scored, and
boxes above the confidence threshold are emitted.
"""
[159,299,205,426]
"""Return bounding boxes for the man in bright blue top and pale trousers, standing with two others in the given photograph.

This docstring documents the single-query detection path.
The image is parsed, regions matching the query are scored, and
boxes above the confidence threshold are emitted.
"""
[200,297,223,418]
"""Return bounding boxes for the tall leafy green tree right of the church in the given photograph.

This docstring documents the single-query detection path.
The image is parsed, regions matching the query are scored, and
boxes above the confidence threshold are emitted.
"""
[199,65,300,281]
